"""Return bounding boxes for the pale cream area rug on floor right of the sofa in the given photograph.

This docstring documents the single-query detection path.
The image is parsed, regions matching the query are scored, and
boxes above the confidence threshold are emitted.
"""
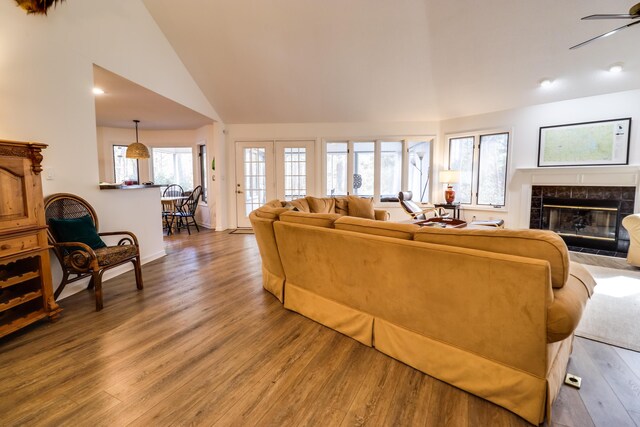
[576,265,640,351]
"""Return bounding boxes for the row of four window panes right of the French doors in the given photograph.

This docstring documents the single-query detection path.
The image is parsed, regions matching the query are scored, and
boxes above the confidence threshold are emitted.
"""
[325,138,432,203]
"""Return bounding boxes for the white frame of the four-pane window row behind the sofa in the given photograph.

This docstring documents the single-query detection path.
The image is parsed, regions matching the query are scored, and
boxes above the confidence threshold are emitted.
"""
[321,135,437,207]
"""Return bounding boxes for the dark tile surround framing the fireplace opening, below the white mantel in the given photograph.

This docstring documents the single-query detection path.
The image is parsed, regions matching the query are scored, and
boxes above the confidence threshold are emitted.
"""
[529,185,636,257]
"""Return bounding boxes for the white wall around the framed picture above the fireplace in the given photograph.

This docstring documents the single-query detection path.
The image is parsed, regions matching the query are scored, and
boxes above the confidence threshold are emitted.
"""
[436,90,640,227]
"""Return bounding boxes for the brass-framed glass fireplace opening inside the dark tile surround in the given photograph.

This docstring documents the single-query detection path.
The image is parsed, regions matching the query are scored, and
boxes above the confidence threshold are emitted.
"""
[540,197,620,251]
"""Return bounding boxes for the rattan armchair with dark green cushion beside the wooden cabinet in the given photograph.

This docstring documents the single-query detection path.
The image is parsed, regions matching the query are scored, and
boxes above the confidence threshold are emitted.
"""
[44,193,143,311]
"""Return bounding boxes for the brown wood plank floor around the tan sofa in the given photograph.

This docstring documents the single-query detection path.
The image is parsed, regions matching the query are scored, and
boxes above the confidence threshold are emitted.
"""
[0,230,640,427]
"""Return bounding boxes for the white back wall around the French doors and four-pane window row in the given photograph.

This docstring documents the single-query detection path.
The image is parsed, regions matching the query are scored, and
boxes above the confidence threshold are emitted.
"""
[226,122,439,228]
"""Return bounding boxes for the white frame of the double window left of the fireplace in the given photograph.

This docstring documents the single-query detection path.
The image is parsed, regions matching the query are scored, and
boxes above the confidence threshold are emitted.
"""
[445,129,512,209]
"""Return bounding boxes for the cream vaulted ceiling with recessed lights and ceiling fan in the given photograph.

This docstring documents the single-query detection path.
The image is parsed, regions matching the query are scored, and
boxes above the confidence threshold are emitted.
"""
[143,0,640,123]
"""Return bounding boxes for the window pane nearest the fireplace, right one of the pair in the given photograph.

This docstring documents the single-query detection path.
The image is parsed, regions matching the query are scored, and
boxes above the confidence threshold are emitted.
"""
[478,133,509,206]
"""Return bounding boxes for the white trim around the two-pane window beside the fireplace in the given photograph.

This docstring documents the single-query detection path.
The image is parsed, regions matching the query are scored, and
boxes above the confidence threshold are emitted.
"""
[438,128,513,212]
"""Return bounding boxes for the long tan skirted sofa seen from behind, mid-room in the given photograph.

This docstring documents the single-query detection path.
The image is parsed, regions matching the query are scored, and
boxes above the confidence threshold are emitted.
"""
[250,203,595,424]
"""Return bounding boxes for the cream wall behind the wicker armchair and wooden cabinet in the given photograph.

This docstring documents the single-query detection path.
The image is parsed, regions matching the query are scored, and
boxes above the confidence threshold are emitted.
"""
[0,0,219,300]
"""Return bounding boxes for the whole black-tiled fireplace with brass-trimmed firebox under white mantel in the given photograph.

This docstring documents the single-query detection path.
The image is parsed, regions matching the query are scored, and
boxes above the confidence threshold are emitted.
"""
[529,185,636,257]
